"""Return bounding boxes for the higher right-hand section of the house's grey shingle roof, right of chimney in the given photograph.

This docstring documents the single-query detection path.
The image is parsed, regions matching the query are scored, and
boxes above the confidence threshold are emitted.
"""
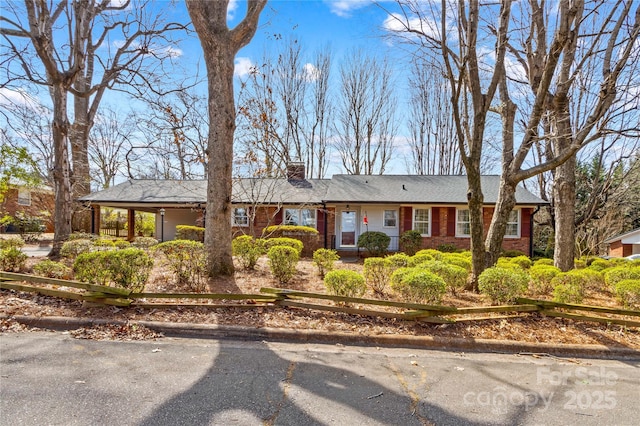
[325,175,547,204]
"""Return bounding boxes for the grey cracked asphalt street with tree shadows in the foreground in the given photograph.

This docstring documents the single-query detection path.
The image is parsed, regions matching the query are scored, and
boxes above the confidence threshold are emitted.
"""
[0,332,640,426]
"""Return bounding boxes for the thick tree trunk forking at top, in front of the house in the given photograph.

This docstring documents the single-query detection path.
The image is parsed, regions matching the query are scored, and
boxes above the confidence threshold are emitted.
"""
[187,0,266,276]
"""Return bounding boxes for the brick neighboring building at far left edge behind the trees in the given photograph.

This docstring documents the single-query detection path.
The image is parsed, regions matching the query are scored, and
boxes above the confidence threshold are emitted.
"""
[0,185,55,232]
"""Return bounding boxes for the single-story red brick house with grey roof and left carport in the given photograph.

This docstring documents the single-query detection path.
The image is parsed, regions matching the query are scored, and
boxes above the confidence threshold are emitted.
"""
[81,163,546,254]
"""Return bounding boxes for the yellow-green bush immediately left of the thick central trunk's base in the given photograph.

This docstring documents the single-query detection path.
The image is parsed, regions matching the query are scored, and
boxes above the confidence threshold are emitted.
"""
[153,240,208,291]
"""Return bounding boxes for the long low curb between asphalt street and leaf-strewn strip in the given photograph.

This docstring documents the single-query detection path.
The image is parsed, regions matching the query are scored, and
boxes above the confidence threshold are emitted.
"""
[5,315,640,360]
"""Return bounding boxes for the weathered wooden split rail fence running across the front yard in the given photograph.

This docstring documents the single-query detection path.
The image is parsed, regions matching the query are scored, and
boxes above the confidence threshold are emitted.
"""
[0,272,640,327]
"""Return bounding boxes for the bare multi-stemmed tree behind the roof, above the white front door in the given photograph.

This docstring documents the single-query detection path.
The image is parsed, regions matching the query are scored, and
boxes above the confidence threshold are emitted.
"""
[336,51,397,175]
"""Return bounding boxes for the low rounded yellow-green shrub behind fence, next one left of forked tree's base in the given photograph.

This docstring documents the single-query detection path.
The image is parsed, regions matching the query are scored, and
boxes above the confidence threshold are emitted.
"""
[391,268,447,304]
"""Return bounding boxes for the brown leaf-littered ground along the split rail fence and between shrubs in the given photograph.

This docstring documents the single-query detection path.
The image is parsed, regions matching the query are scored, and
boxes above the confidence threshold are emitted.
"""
[0,250,640,349]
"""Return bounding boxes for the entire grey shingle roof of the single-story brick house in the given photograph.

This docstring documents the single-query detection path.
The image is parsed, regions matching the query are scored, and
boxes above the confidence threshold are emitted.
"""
[80,175,546,205]
